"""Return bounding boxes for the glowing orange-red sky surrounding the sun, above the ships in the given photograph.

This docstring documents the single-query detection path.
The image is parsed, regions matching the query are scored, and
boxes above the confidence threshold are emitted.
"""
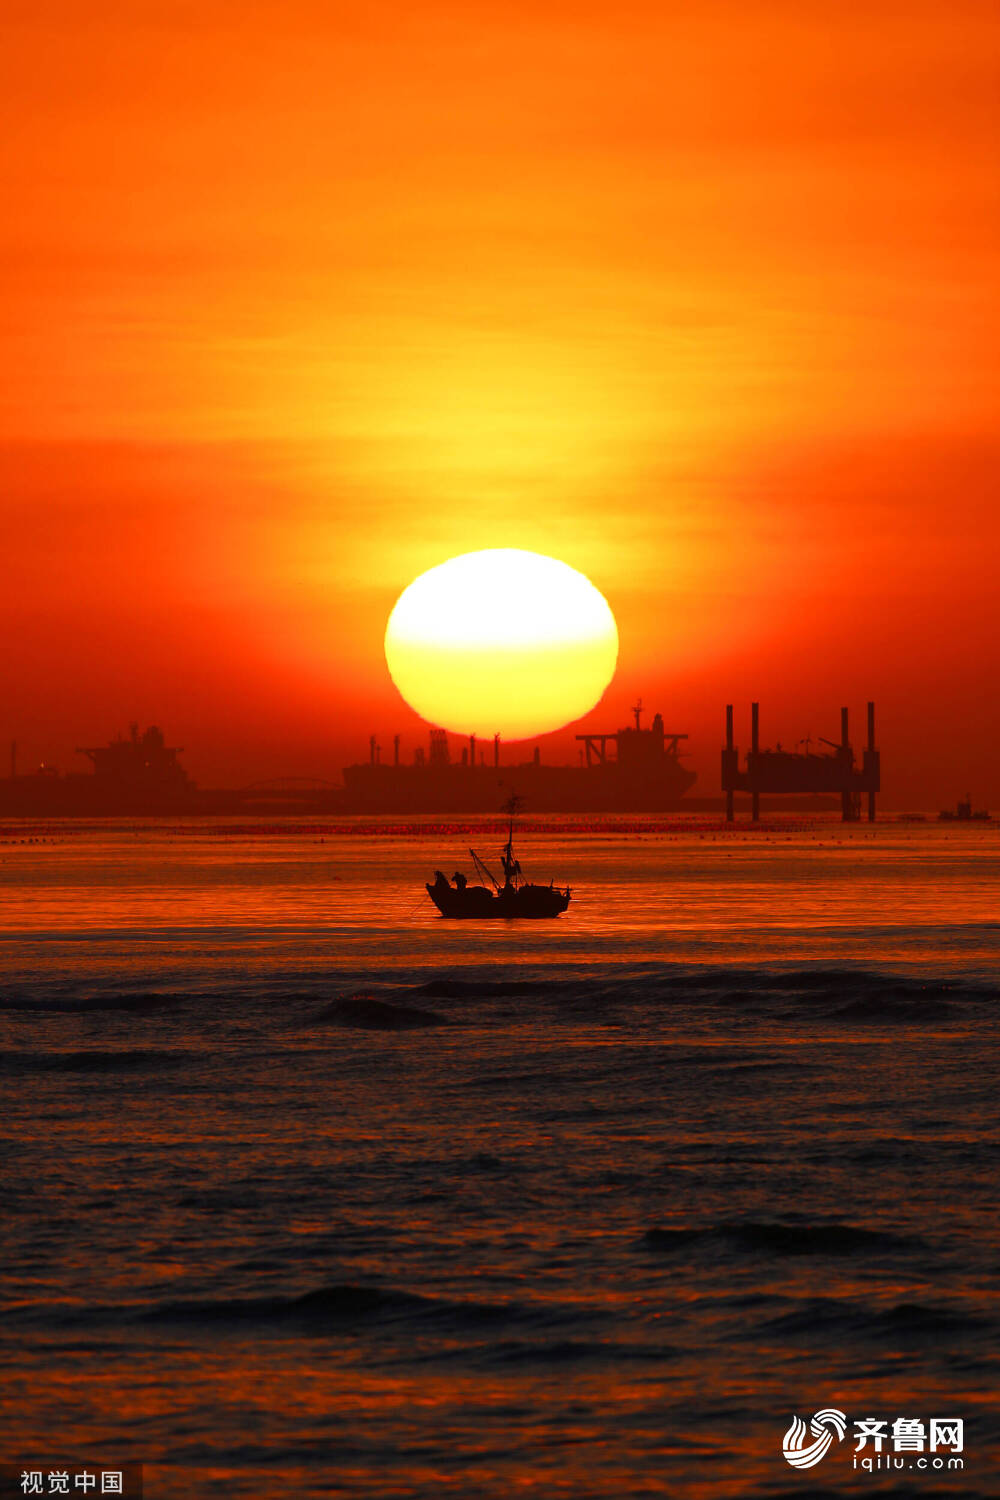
[0,0,1000,806]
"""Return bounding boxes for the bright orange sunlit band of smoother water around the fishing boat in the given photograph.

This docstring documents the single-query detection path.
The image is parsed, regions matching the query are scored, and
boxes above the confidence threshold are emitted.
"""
[0,821,1000,974]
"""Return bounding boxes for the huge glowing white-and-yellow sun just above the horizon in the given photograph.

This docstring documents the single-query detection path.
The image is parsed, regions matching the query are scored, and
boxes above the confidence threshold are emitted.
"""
[385,548,618,740]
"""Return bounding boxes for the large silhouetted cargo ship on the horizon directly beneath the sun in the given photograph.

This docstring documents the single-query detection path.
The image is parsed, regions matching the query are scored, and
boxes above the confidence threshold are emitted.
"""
[343,701,697,815]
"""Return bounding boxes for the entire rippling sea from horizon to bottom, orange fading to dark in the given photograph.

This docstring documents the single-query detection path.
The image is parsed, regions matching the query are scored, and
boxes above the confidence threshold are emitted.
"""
[0,819,1000,1500]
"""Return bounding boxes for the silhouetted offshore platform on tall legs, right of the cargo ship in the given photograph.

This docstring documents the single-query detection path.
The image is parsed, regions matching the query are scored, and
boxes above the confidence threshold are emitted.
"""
[723,704,880,824]
